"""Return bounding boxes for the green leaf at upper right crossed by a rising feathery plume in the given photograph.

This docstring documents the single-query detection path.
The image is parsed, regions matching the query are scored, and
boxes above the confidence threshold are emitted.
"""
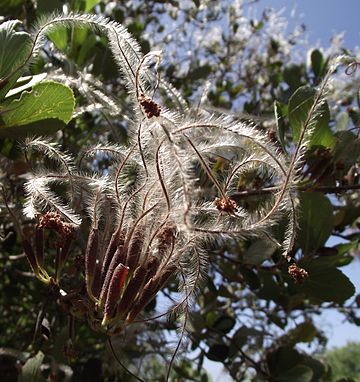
[289,86,335,148]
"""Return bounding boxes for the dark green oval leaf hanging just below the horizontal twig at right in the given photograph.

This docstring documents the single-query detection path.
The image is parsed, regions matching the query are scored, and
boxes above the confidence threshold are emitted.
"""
[298,192,334,254]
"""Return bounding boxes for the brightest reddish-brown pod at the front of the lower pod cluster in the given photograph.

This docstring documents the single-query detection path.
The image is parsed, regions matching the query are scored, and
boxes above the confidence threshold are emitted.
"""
[101,264,129,326]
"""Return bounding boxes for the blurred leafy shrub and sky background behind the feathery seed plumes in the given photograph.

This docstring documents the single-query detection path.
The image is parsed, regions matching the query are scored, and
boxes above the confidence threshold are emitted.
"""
[0,0,360,381]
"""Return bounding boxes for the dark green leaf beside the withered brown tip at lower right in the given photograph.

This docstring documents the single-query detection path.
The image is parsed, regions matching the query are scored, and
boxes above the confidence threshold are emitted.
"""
[299,258,355,304]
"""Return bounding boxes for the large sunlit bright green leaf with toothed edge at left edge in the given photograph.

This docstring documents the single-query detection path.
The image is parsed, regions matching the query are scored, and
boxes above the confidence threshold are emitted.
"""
[0,81,75,133]
